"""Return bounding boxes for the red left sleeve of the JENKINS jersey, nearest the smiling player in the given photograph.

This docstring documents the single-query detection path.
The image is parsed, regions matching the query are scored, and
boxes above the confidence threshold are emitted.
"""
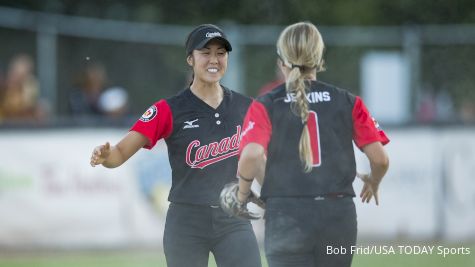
[239,100,272,155]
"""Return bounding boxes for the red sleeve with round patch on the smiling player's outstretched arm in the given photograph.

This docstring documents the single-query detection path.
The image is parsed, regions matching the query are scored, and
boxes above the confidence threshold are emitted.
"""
[130,100,173,149]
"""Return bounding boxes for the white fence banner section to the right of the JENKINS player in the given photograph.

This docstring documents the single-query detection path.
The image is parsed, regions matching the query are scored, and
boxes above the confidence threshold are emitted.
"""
[354,128,475,241]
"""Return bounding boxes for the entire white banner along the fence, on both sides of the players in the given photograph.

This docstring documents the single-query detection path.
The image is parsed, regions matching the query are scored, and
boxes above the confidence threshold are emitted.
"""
[0,128,475,248]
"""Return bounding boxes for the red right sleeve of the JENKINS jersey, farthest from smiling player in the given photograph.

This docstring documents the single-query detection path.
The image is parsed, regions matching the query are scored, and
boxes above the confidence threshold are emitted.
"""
[353,96,389,149]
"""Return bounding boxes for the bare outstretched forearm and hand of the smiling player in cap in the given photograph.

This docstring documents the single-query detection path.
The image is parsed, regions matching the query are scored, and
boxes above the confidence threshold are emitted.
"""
[91,131,148,168]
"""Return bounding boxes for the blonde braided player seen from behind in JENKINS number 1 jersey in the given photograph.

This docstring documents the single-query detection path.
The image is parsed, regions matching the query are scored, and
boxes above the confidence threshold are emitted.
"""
[236,22,389,267]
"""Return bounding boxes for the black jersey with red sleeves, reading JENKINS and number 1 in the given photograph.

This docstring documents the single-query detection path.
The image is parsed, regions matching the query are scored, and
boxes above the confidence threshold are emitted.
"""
[240,81,389,199]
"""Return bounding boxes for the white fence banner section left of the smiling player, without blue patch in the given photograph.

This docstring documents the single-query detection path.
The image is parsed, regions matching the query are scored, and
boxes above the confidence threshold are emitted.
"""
[0,129,167,247]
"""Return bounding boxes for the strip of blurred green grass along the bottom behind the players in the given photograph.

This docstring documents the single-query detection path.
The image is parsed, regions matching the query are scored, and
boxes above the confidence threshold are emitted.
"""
[0,246,475,267]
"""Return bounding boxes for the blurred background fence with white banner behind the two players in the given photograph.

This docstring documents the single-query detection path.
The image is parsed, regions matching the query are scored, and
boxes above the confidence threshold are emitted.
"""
[0,1,475,253]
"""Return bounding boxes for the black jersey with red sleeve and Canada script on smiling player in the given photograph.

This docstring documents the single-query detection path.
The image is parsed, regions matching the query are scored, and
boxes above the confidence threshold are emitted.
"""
[131,87,251,205]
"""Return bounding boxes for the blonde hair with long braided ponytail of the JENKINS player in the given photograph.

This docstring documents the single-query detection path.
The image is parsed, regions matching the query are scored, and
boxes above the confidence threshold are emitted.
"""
[277,22,324,173]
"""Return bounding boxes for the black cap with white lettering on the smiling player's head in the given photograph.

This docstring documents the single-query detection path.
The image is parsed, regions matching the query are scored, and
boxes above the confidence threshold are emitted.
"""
[185,24,233,55]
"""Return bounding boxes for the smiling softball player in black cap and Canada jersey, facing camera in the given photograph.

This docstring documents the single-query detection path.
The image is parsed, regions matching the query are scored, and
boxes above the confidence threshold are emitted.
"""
[91,24,261,267]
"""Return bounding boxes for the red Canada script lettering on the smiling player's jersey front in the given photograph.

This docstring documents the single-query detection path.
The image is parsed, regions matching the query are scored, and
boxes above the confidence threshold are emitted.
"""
[186,125,241,169]
